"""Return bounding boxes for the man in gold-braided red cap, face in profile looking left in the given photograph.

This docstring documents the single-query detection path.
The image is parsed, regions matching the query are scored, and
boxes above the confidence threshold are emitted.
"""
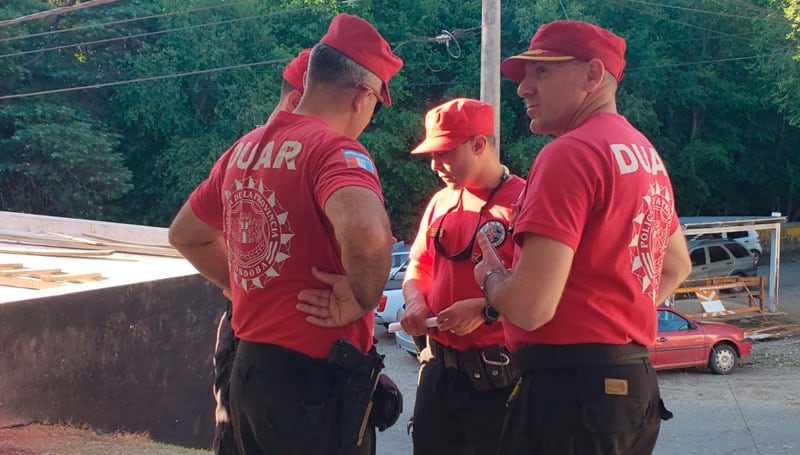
[475,21,691,455]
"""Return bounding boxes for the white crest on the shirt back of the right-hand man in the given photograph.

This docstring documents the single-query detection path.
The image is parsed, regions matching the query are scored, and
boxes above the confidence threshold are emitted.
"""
[628,183,675,304]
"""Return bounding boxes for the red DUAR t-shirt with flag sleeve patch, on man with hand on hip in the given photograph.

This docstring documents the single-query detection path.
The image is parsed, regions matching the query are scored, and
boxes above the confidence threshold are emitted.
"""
[189,112,383,358]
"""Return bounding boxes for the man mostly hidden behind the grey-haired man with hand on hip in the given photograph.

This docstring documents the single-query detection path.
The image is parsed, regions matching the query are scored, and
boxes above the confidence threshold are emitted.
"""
[211,49,311,455]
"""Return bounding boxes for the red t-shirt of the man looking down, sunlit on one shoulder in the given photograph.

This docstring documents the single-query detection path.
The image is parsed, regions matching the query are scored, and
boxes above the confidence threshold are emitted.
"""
[409,176,525,351]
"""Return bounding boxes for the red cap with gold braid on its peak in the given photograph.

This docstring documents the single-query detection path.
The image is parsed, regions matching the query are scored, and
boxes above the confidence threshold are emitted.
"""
[502,21,625,82]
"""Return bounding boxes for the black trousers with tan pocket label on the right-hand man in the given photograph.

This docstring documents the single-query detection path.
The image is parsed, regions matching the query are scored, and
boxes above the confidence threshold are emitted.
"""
[497,345,669,455]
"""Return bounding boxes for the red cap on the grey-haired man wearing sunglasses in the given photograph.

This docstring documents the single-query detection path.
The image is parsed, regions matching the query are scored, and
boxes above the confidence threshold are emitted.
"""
[320,13,403,106]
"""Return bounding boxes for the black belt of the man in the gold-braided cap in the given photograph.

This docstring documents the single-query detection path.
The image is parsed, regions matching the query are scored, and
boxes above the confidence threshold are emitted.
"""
[511,343,650,373]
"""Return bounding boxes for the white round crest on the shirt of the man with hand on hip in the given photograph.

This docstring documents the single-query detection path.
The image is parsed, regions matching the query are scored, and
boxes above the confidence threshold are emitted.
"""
[225,177,294,291]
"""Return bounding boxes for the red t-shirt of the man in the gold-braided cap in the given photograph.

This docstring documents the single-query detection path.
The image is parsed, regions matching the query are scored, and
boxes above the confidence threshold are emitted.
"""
[505,113,678,349]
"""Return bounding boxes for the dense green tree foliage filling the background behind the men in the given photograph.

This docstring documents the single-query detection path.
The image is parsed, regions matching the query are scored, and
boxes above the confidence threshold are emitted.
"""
[0,0,800,240]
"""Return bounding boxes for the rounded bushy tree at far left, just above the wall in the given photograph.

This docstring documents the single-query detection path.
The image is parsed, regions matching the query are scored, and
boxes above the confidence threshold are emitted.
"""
[0,103,132,219]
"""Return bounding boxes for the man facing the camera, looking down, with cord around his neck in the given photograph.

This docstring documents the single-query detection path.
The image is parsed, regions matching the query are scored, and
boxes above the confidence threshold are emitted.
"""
[401,98,525,455]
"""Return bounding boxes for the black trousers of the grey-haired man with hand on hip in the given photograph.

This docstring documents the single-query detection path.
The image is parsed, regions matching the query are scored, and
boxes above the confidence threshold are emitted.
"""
[230,341,375,455]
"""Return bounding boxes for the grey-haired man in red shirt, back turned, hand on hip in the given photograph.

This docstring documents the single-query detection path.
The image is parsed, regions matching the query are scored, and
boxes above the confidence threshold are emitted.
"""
[170,14,402,455]
